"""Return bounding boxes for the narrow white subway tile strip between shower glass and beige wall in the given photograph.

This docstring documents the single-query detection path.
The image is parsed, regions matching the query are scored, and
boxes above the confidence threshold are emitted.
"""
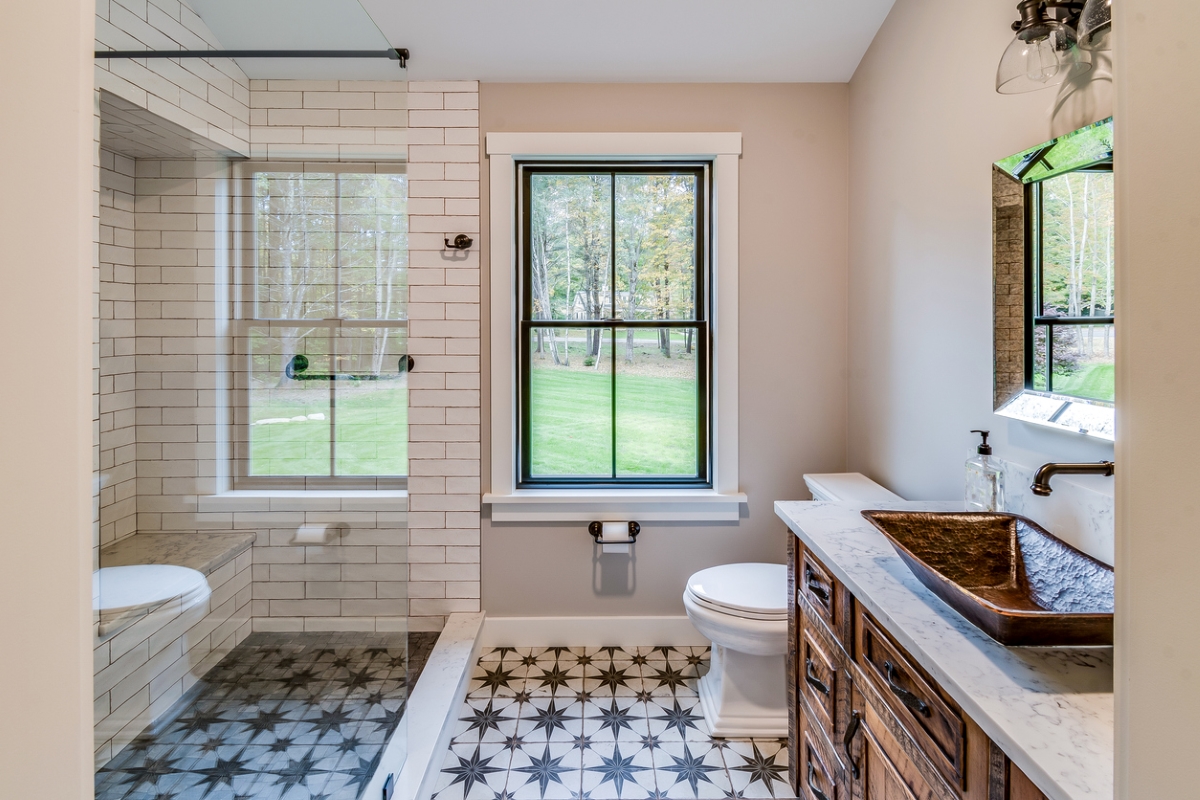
[408,80,482,626]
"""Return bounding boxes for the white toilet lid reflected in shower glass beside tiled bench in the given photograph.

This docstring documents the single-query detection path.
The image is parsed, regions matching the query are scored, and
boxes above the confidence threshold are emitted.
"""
[91,564,212,636]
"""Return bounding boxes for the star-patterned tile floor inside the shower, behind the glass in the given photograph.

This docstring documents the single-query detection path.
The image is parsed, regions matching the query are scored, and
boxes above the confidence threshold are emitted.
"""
[96,633,437,800]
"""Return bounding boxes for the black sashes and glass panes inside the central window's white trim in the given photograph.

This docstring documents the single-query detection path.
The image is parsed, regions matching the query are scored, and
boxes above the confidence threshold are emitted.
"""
[517,163,710,487]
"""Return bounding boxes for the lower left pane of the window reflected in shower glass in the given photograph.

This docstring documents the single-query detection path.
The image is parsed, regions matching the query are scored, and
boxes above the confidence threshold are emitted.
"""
[247,326,332,475]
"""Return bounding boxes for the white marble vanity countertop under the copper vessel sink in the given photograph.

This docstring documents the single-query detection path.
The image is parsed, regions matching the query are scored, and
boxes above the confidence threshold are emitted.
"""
[775,501,1114,800]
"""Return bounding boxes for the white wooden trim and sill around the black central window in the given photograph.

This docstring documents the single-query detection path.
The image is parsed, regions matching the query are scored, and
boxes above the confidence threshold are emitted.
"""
[484,133,746,522]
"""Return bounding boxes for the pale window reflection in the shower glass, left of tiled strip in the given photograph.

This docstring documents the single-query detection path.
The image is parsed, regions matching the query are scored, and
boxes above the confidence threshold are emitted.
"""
[232,164,408,488]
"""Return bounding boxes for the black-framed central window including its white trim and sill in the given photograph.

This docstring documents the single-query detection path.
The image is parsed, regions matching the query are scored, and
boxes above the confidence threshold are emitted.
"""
[482,132,746,523]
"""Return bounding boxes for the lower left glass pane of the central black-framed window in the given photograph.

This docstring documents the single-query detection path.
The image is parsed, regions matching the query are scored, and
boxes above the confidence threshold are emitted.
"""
[529,327,612,477]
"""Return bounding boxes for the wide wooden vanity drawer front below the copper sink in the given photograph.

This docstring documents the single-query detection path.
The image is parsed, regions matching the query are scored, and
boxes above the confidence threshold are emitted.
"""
[856,607,967,788]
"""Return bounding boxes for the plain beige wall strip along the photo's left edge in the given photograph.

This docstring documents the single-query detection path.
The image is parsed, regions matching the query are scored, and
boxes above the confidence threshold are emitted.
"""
[0,0,95,800]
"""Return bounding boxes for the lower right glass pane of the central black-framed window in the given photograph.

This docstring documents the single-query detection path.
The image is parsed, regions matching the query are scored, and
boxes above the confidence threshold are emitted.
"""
[616,329,700,477]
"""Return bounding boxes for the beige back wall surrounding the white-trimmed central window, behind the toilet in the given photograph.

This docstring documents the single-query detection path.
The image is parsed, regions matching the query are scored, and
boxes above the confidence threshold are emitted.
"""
[480,84,847,616]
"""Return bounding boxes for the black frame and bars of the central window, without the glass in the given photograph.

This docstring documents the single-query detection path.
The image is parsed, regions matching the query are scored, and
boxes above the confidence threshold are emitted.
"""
[515,158,714,489]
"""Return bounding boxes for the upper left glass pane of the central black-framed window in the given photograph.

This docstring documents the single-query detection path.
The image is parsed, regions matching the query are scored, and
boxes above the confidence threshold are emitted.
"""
[529,174,613,319]
